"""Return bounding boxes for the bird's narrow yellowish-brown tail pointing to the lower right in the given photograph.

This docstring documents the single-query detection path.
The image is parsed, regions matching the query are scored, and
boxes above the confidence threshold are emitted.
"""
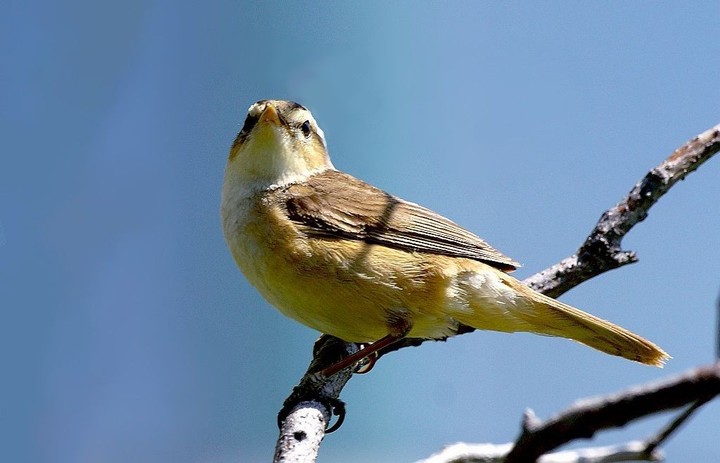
[458,272,670,367]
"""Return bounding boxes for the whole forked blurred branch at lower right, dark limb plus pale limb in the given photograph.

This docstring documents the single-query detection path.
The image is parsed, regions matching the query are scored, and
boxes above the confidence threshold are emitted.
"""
[418,363,720,463]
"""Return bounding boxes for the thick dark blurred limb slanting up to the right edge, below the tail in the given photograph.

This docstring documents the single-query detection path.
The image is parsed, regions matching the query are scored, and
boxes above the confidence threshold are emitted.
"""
[505,363,720,463]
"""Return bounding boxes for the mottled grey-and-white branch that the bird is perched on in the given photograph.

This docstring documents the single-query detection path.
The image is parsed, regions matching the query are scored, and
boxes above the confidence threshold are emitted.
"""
[274,125,720,462]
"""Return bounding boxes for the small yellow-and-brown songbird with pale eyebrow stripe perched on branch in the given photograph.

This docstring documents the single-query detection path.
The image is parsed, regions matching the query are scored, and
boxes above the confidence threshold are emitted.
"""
[221,100,669,372]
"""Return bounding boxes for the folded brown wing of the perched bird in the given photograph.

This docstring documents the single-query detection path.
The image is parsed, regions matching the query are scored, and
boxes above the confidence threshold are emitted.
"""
[283,170,520,271]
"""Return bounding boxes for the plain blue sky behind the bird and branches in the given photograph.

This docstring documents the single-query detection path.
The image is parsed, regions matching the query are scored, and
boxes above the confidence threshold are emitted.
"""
[0,0,720,463]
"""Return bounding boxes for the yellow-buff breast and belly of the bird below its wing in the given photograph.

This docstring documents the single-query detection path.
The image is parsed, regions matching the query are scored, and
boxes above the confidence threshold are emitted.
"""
[225,199,464,342]
